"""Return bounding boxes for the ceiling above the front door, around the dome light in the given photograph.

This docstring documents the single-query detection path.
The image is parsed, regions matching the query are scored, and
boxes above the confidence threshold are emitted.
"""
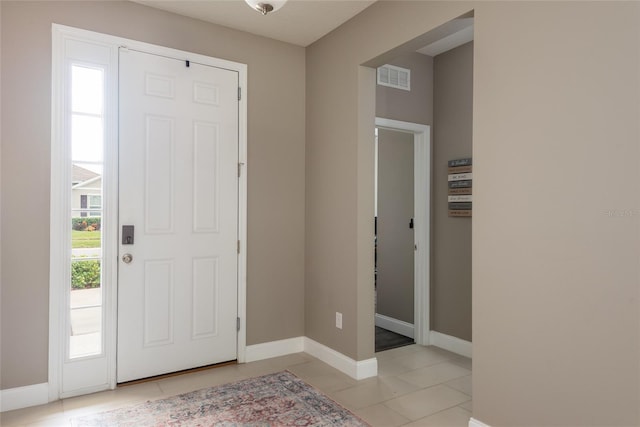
[133,0,375,47]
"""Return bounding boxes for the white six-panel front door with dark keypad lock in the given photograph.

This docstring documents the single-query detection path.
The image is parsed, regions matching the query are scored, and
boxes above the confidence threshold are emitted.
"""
[117,49,239,382]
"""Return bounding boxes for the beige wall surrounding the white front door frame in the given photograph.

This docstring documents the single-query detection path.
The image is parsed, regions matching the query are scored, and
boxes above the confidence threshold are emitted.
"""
[0,1,305,389]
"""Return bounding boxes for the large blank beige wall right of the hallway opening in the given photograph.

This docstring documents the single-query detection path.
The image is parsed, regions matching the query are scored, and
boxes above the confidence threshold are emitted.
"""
[472,2,640,425]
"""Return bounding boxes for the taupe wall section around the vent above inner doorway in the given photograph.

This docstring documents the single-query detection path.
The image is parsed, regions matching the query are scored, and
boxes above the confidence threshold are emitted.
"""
[376,52,433,125]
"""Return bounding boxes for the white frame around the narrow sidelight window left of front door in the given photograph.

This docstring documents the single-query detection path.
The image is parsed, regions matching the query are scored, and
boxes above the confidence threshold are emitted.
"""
[48,24,118,401]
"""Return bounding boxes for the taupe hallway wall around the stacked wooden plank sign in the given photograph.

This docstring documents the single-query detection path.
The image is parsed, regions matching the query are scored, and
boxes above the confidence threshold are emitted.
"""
[431,42,473,341]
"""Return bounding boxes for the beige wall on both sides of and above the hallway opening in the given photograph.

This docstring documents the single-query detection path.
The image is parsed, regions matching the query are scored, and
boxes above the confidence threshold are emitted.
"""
[306,1,640,426]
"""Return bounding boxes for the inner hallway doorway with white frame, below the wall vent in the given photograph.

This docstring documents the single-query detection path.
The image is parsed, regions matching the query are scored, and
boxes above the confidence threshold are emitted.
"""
[374,118,431,351]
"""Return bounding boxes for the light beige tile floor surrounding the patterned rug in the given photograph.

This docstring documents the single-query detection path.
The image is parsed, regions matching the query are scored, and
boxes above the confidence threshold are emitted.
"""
[0,345,471,427]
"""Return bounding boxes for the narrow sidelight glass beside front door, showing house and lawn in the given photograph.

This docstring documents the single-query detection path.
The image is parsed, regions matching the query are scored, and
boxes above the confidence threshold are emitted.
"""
[68,64,104,358]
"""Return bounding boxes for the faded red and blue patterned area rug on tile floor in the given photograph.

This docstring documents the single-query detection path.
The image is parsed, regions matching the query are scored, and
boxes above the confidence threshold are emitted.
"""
[72,372,368,427]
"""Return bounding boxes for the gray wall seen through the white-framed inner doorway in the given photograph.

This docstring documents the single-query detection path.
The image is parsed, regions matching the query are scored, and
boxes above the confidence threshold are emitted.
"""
[376,129,415,324]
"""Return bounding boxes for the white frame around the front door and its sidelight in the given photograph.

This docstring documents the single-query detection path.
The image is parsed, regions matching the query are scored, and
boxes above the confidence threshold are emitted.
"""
[48,24,247,401]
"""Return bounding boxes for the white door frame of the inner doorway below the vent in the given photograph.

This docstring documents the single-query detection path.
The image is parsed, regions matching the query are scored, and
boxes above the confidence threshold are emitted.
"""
[376,117,431,345]
